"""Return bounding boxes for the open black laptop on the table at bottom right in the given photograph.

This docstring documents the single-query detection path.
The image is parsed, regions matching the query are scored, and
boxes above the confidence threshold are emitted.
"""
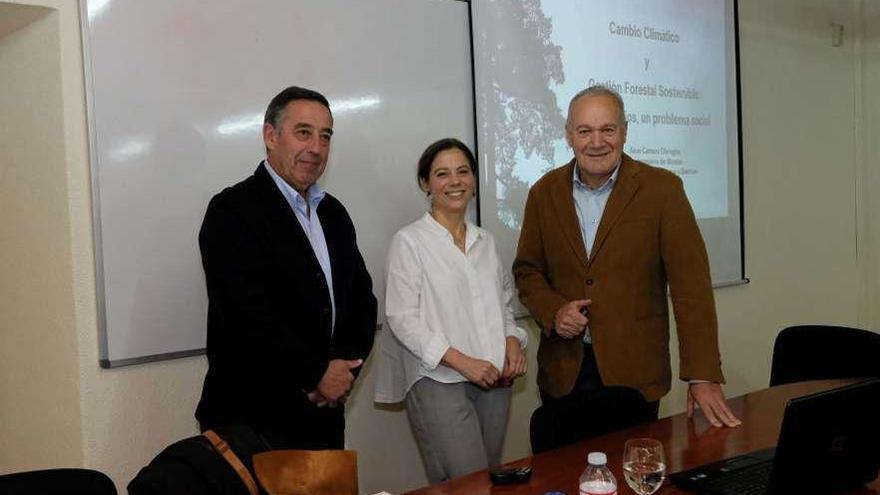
[669,379,880,495]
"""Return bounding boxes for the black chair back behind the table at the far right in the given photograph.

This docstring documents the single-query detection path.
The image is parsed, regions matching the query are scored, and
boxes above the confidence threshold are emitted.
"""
[770,325,880,387]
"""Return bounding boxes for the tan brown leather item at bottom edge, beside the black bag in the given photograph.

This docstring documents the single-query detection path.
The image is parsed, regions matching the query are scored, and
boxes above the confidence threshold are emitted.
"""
[253,450,358,495]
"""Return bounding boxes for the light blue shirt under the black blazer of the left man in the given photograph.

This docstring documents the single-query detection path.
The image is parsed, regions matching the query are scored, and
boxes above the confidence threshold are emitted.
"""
[263,160,336,334]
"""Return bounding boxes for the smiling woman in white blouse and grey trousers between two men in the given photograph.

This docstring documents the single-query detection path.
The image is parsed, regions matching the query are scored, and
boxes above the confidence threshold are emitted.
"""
[376,139,527,483]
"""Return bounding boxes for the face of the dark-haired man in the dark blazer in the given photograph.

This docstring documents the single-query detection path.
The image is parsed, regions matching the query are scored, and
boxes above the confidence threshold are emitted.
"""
[263,100,333,196]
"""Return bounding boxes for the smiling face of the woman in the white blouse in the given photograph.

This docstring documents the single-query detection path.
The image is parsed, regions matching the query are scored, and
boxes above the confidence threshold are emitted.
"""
[422,148,474,213]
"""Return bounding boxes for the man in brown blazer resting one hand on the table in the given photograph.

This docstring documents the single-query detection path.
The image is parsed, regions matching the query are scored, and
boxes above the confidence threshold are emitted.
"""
[513,86,739,454]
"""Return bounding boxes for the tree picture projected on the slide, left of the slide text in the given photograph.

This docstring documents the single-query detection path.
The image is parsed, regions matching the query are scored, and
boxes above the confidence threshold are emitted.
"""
[474,0,565,232]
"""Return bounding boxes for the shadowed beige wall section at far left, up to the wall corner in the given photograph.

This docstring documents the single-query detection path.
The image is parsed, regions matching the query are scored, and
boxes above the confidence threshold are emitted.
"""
[0,0,82,471]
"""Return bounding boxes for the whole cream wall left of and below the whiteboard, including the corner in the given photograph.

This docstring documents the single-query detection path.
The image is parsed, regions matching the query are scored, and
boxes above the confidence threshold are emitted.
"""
[0,0,204,485]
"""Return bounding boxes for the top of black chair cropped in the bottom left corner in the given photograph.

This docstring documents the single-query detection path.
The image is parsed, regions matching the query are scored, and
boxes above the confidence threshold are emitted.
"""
[0,469,117,495]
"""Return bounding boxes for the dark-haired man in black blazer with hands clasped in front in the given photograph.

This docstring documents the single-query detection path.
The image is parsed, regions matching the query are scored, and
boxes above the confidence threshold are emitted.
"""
[196,87,376,449]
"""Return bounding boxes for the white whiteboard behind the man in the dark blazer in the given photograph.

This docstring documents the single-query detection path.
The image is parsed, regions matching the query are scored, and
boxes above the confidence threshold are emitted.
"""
[80,0,474,367]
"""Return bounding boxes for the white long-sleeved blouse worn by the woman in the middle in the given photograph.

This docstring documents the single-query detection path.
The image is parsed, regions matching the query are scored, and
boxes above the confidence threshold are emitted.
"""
[376,213,528,402]
